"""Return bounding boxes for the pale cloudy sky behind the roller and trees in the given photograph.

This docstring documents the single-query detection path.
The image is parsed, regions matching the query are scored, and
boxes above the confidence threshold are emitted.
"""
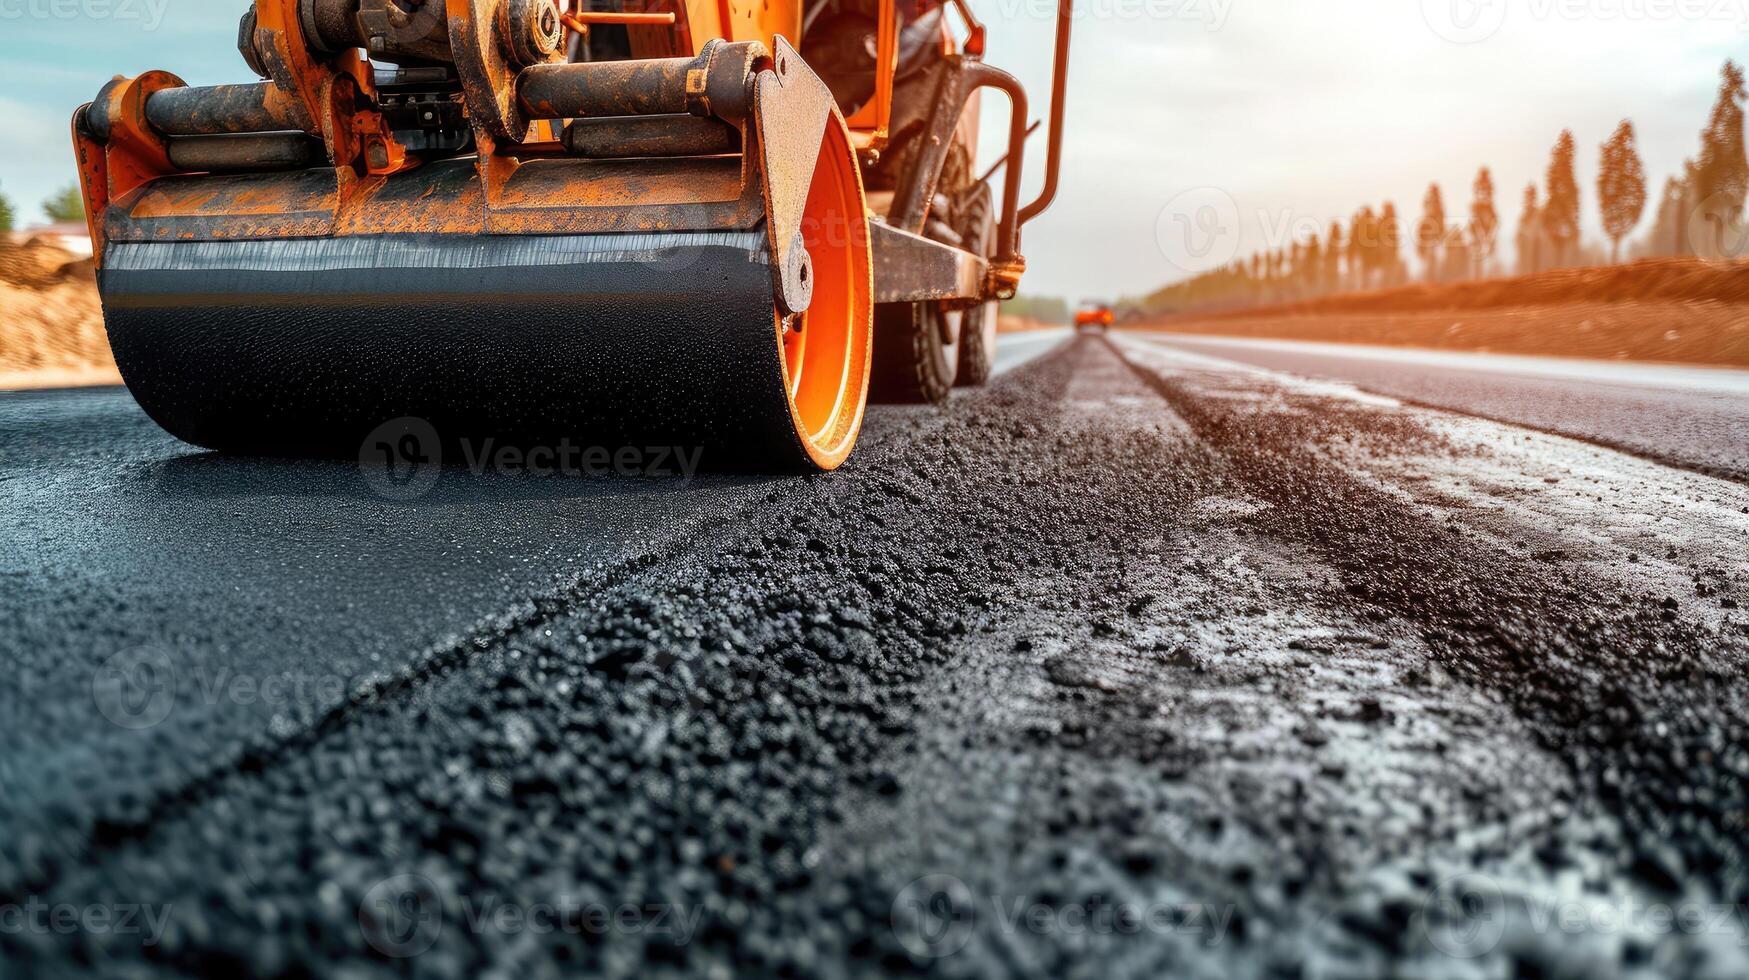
[0,0,1749,301]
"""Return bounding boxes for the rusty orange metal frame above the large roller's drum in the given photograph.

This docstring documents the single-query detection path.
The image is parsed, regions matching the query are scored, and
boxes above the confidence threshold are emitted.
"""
[73,0,1072,306]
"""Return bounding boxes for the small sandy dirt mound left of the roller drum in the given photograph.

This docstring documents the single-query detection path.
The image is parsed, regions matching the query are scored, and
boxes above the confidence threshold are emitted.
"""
[0,240,121,389]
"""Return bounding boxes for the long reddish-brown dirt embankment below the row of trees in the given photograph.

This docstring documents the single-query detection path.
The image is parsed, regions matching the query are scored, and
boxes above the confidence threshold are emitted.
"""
[1147,259,1749,368]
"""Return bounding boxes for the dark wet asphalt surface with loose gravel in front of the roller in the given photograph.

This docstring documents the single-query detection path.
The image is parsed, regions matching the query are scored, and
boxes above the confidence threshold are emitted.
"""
[0,336,1749,978]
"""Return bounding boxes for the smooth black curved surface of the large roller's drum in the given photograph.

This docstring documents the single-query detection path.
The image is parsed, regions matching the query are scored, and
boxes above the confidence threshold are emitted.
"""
[100,231,803,469]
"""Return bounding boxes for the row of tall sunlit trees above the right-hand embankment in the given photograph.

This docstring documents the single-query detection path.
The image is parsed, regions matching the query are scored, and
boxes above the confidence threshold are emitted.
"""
[1144,61,1749,312]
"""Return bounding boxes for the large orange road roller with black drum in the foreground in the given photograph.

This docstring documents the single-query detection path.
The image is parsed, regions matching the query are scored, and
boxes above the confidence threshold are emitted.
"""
[73,0,1070,471]
